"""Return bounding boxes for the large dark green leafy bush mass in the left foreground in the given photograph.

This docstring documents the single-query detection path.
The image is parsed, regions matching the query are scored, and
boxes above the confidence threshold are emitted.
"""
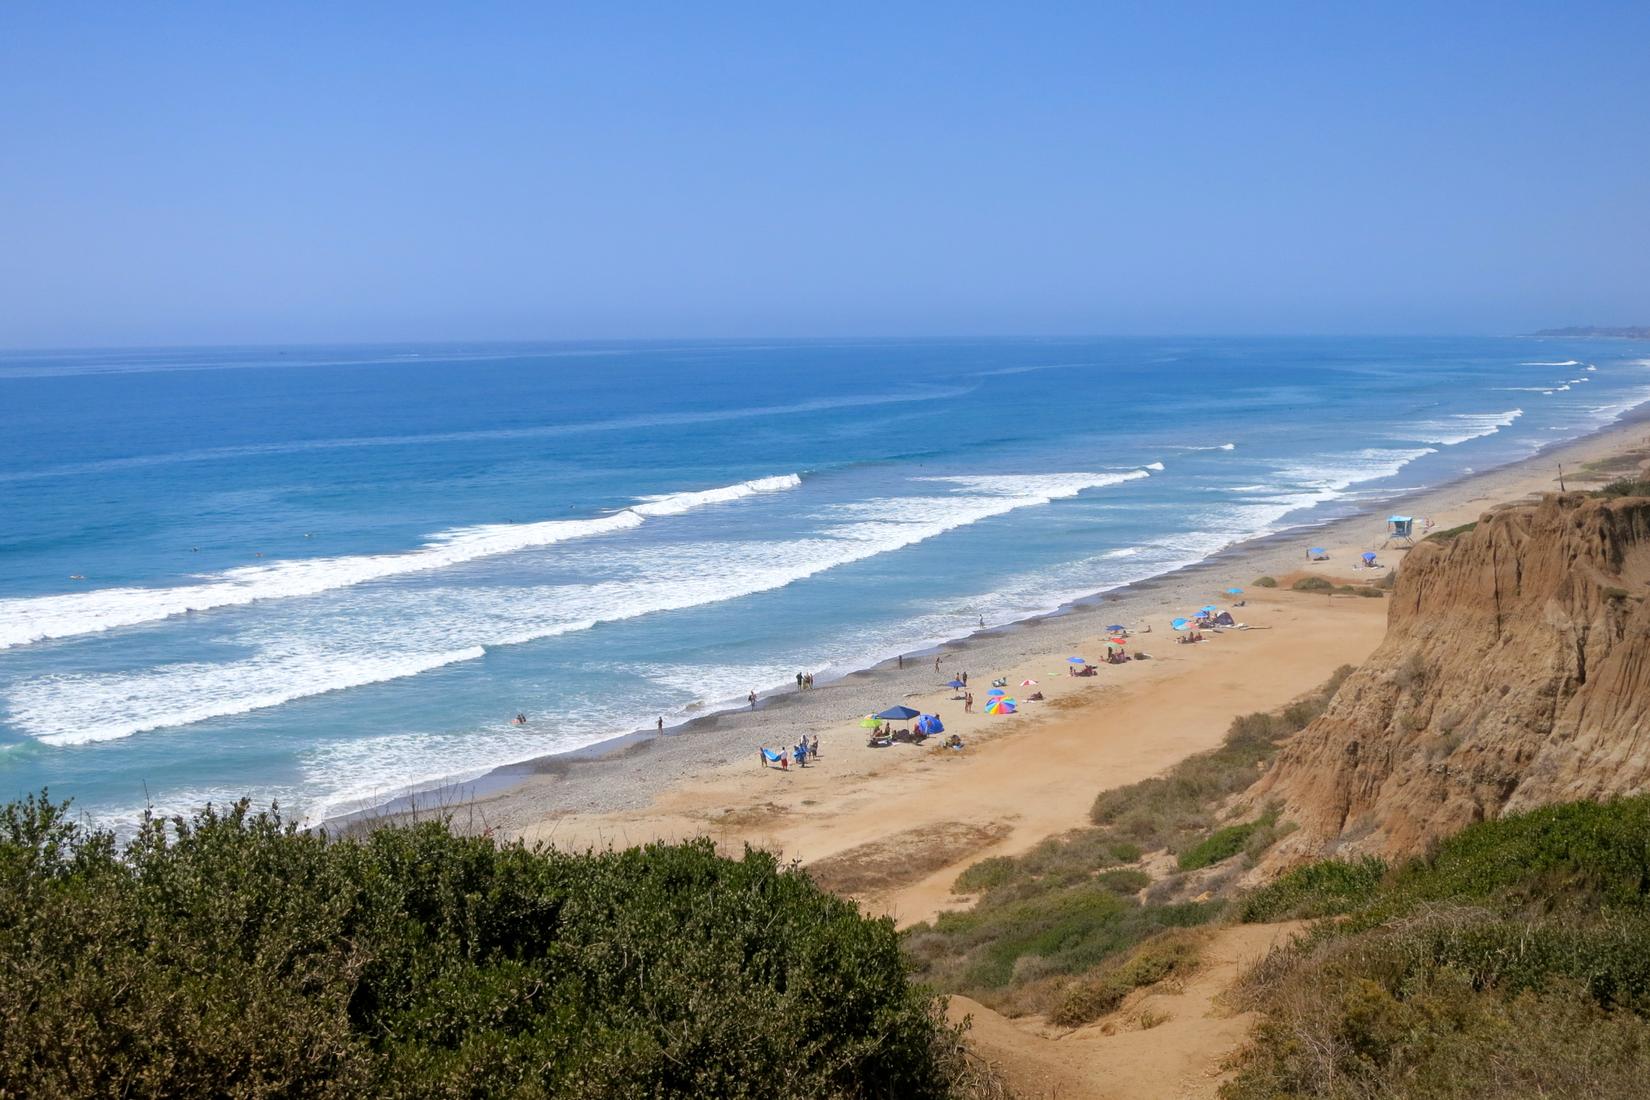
[0,795,970,1097]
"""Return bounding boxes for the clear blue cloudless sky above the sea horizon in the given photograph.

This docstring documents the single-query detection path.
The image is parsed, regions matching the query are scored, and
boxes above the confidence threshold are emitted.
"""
[0,0,1650,346]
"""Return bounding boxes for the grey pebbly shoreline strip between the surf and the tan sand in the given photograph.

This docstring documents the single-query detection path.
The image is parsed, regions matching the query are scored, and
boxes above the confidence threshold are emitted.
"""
[317,402,1650,834]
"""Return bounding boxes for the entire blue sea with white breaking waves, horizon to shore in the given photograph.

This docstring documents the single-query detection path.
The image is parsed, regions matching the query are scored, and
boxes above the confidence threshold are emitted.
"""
[0,338,1650,820]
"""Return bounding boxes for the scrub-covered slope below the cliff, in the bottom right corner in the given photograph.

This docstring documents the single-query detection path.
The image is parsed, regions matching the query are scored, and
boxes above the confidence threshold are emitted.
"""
[1224,797,1650,1100]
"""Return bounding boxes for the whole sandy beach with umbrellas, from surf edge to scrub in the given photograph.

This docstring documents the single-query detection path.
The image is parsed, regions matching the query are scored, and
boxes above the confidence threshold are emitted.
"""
[367,410,1650,924]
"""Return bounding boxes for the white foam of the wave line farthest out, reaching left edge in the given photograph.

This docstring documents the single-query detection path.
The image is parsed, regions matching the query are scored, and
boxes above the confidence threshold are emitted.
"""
[0,473,802,650]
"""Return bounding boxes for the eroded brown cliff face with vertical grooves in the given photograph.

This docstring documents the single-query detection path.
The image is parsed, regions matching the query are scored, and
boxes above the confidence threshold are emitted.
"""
[1251,493,1650,863]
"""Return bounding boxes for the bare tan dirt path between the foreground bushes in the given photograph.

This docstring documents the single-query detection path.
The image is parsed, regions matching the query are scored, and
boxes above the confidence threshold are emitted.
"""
[950,922,1304,1100]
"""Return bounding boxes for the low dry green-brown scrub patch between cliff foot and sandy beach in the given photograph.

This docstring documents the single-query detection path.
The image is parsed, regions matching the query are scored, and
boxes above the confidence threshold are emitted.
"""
[906,666,1351,1026]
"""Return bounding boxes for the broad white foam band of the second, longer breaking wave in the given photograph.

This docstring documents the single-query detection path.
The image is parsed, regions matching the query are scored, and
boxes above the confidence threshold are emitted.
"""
[8,470,1150,744]
